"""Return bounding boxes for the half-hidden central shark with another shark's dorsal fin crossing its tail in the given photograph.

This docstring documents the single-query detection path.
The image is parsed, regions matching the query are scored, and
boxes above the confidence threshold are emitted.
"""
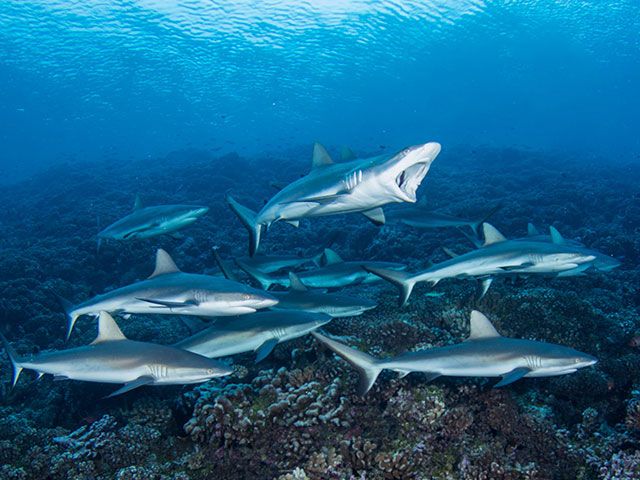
[236,248,406,290]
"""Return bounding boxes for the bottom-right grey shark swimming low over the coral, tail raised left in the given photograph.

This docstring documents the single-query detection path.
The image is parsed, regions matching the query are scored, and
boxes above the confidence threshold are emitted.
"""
[312,310,598,395]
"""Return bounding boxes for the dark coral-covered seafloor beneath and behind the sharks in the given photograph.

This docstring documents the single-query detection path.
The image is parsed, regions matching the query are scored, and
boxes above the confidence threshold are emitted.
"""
[0,147,640,480]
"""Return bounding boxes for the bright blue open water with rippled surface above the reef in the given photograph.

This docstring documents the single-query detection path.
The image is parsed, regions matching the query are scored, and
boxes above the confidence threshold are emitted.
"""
[0,0,640,180]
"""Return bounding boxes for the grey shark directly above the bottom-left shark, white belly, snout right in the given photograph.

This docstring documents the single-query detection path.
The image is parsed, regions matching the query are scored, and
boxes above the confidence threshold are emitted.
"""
[61,249,278,338]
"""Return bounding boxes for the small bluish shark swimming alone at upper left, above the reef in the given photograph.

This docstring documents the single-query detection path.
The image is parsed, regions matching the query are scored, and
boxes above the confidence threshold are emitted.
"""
[98,197,209,242]
